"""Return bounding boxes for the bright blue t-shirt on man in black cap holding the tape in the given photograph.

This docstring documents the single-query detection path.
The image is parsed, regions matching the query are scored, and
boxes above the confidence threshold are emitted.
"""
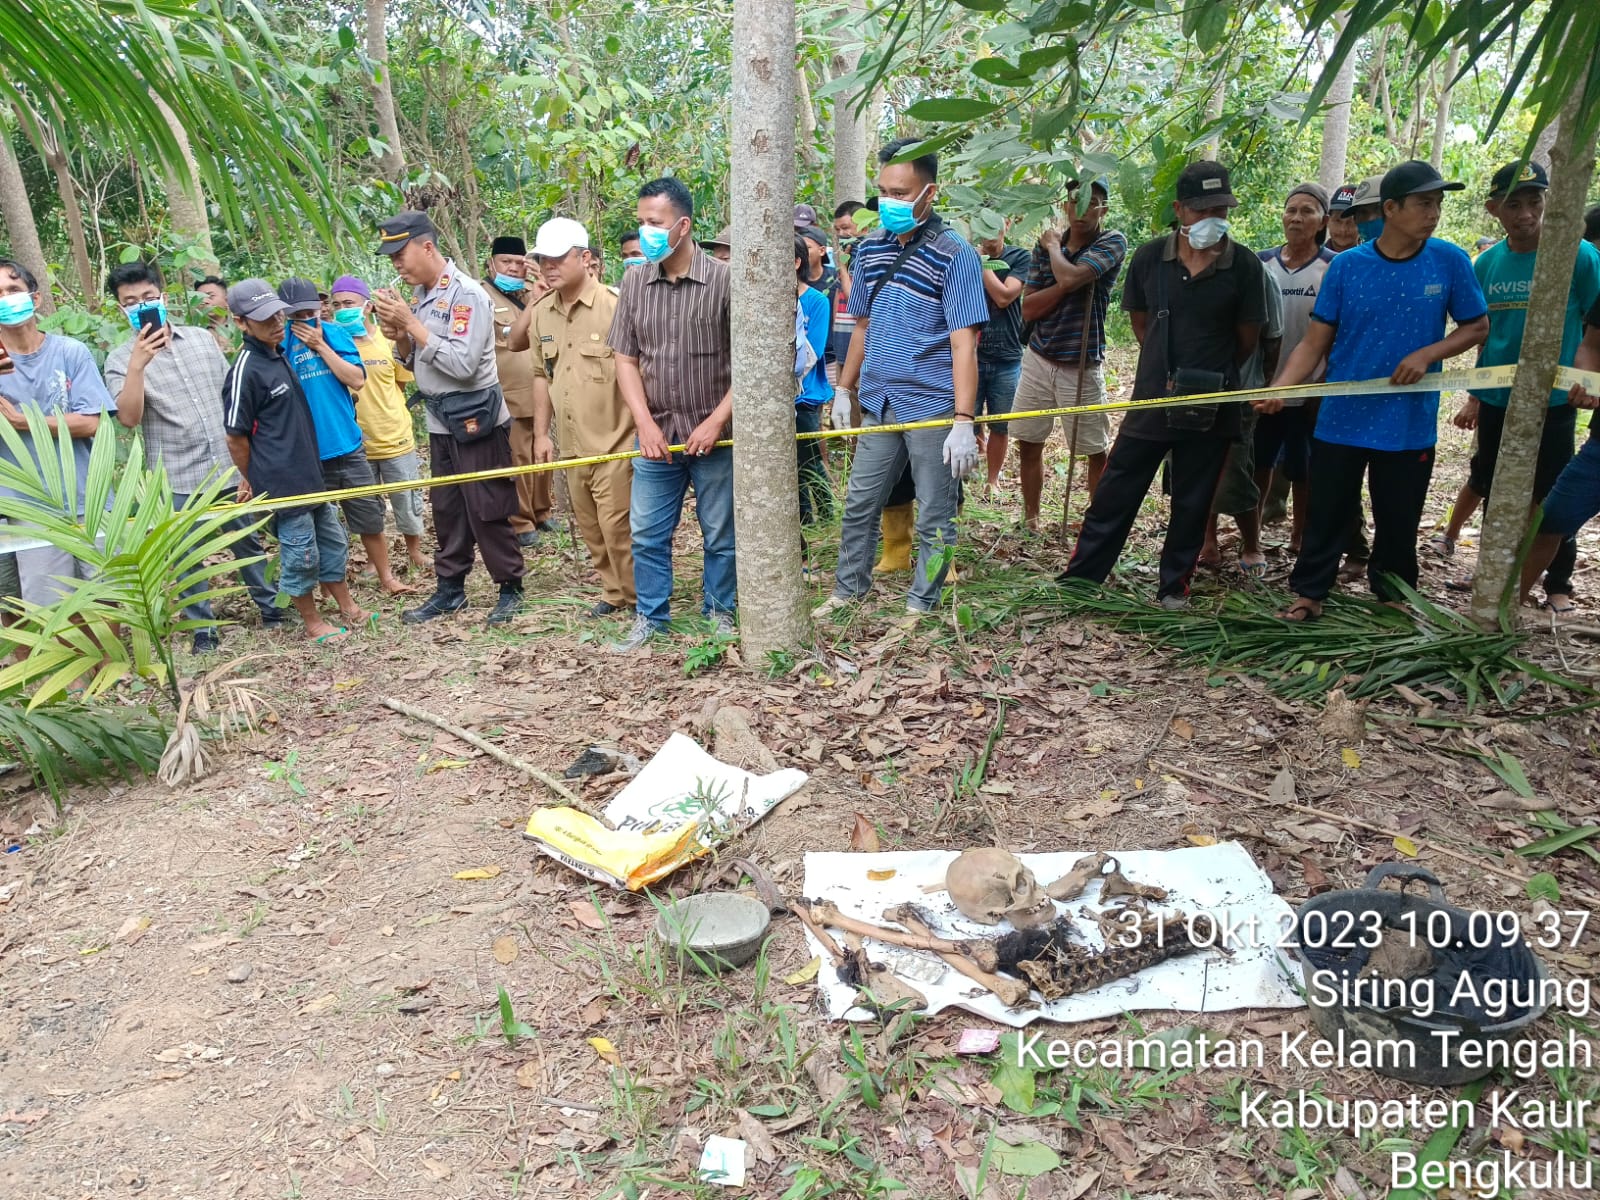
[1310,237,1488,450]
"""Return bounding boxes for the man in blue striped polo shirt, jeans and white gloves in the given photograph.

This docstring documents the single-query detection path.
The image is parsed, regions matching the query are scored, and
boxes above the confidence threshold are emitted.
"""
[811,138,989,618]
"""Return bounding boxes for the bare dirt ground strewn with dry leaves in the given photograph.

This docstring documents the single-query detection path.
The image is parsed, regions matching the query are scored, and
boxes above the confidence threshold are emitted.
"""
[0,392,1600,1200]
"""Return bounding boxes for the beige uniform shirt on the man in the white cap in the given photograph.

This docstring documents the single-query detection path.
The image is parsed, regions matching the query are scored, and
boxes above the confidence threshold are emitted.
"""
[531,280,635,458]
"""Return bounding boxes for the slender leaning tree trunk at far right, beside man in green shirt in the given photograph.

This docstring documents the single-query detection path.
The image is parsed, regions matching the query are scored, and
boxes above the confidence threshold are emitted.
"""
[1469,85,1595,629]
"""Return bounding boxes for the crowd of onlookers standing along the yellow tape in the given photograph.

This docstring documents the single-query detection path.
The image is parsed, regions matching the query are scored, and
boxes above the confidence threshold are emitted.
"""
[0,149,1600,653]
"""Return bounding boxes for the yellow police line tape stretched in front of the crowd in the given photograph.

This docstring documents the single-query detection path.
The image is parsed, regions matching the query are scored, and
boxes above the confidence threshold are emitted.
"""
[214,363,1600,514]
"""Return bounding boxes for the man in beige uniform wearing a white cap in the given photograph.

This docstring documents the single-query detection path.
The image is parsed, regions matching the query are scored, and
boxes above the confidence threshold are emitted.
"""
[533,216,635,616]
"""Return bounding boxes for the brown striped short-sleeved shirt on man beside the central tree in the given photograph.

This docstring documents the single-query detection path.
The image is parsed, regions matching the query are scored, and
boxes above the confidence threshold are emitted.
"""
[608,246,733,445]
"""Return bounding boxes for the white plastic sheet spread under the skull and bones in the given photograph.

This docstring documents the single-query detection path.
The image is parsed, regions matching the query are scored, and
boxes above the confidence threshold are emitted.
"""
[802,842,1304,1027]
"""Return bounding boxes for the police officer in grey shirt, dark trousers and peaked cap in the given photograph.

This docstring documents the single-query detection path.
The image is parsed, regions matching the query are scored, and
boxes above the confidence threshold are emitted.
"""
[373,213,523,626]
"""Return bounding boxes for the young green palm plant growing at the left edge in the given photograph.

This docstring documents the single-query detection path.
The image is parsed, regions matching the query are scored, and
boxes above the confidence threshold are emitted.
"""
[0,410,266,803]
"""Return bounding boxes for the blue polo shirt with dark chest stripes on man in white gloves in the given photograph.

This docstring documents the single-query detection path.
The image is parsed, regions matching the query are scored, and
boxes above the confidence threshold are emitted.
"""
[850,216,989,421]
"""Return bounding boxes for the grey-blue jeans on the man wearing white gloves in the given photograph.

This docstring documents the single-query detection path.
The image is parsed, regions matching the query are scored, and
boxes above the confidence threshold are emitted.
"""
[834,405,958,613]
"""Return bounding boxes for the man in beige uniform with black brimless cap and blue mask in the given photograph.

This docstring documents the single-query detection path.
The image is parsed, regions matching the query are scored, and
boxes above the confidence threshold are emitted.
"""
[483,235,555,549]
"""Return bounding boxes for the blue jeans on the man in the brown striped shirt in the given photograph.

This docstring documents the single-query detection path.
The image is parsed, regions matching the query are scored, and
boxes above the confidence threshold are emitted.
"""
[629,446,738,626]
